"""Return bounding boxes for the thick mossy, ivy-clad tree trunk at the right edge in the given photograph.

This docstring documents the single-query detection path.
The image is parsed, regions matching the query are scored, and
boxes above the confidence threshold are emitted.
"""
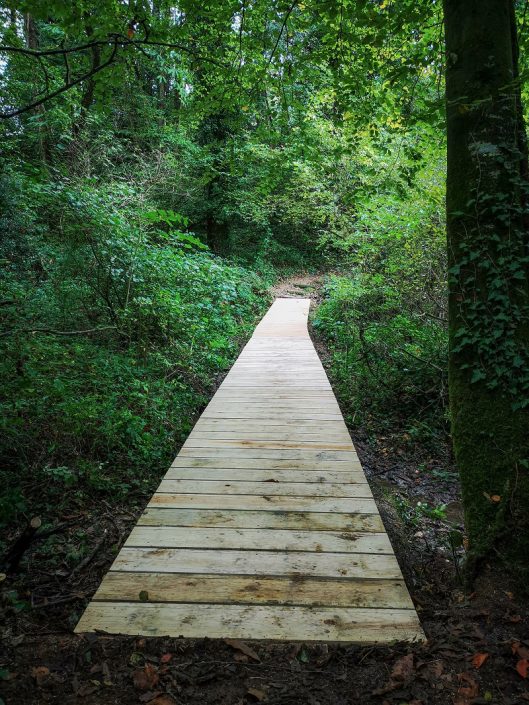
[444,0,529,573]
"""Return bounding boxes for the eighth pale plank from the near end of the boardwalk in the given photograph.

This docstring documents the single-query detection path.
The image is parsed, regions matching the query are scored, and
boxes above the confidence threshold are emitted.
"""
[164,468,365,486]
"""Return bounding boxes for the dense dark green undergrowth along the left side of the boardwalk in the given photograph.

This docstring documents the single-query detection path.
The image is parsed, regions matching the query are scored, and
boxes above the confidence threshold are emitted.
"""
[0,169,267,521]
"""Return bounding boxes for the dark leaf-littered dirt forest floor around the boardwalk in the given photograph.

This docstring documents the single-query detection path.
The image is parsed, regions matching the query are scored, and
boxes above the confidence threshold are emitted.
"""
[0,274,529,705]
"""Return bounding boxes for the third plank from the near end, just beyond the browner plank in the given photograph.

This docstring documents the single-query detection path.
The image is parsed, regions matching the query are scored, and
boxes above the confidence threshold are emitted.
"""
[111,546,401,580]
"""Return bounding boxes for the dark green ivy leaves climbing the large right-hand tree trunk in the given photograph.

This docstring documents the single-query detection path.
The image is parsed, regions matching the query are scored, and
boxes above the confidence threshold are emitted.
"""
[449,137,529,411]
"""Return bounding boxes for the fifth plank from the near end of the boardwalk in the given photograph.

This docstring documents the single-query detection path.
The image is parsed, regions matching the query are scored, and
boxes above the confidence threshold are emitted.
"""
[138,507,384,533]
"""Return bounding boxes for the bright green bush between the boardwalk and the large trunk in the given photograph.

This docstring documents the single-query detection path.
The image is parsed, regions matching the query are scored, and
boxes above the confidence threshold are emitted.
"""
[313,156,447,443]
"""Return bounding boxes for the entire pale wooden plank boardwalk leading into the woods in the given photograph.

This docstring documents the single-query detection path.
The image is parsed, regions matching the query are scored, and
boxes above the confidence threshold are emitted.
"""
[76,299,424,643]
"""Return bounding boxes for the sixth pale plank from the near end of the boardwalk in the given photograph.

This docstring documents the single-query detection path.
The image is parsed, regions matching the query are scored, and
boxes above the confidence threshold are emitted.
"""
[148,493,377,514]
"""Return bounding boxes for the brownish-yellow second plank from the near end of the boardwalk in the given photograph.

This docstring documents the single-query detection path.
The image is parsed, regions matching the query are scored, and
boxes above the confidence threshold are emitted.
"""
[94,571,413,609]
